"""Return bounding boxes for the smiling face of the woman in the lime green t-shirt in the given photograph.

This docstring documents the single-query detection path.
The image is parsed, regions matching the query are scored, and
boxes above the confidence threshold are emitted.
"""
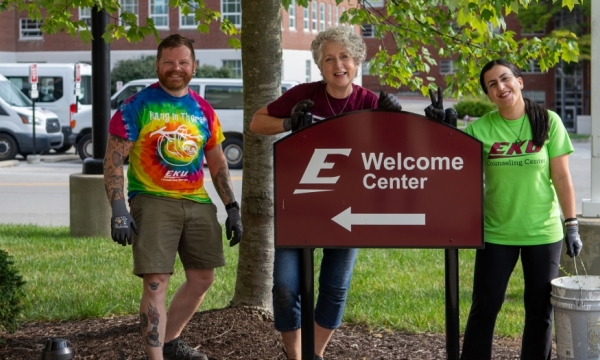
[483,65,524,113]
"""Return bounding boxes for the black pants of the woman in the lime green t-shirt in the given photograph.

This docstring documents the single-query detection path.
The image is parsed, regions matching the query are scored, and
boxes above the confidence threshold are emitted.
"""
[461,241,562,360]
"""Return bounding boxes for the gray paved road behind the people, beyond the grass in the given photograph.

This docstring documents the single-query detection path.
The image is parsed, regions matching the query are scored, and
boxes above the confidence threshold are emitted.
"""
[0,142,591,226]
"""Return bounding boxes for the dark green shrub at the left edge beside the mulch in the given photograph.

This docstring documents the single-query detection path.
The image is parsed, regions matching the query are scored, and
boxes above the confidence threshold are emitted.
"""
[0,249,25,334]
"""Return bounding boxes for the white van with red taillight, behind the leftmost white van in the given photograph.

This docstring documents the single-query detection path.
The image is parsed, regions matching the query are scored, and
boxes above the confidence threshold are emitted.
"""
[0,63,92,152]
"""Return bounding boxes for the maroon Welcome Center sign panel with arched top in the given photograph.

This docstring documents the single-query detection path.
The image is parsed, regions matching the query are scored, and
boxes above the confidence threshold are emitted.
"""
[273,110,483,248]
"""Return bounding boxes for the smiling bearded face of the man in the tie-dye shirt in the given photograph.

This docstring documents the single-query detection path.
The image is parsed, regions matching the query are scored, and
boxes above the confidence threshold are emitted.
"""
[156,46,196,96]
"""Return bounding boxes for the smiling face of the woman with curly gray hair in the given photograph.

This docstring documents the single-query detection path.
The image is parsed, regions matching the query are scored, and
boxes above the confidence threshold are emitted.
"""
[320,41,357,97]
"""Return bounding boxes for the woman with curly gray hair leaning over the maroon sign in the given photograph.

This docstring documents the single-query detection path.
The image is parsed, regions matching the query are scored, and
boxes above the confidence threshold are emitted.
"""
[250,27,402,359]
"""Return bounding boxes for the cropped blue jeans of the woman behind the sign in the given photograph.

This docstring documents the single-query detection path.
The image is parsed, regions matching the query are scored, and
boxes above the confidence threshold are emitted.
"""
[273,248,358,331]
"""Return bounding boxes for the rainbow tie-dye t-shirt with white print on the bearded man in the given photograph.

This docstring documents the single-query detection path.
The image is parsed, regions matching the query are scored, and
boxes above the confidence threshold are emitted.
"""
[109,83,225,203]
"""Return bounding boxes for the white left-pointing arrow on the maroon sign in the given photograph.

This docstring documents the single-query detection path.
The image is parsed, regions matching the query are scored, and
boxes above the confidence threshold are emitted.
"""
[331,207,425,232]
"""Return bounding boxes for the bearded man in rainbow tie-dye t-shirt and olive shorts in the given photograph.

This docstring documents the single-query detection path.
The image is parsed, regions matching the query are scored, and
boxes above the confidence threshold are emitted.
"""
[104,34,243,360]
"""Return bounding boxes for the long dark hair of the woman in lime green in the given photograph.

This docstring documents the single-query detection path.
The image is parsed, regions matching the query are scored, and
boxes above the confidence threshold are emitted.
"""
[479,59,550,146]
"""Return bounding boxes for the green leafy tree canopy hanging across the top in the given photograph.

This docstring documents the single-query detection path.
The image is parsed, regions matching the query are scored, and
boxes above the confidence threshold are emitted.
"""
[0,0,583,97]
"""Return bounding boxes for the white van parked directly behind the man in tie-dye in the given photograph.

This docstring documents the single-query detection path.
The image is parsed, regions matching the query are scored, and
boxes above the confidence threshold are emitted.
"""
[70,78,299,169]
